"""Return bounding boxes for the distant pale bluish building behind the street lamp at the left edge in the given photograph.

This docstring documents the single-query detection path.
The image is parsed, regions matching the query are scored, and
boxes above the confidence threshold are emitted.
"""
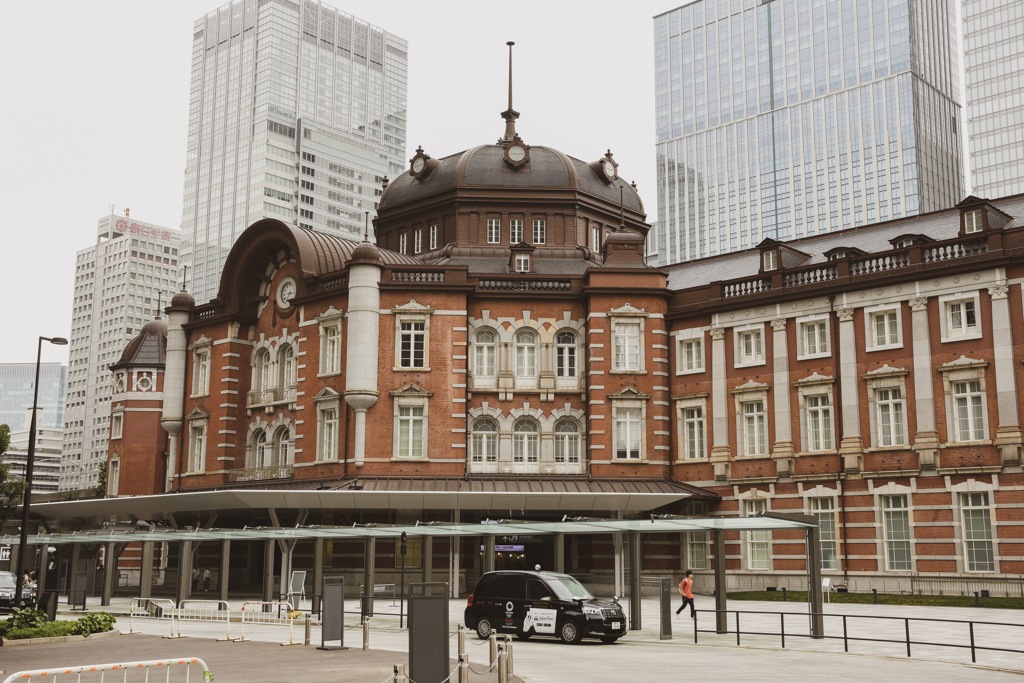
[0,362,68,432]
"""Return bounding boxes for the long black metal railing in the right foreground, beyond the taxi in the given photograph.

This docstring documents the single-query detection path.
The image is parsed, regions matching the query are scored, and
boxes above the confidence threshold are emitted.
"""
[693,609,1024,664]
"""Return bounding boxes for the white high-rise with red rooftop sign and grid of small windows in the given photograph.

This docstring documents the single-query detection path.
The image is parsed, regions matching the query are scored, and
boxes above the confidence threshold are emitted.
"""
[60,211,181,490]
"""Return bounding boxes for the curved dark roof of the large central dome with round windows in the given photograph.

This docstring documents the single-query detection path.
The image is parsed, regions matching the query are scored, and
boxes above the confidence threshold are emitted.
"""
[380,144,643,213]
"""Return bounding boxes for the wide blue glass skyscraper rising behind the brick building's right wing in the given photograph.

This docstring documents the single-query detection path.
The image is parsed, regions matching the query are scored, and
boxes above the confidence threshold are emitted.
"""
[648,0,964,264]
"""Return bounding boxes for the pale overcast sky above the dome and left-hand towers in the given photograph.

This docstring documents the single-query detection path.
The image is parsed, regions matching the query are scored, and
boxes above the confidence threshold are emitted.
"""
[0,0,667,364]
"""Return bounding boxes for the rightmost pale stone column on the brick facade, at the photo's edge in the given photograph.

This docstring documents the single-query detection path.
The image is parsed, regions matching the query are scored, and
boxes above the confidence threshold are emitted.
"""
[988,284,1024,465]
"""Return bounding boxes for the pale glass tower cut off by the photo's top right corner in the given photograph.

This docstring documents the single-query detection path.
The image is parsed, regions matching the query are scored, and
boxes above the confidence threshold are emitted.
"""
[963,0,1024,199]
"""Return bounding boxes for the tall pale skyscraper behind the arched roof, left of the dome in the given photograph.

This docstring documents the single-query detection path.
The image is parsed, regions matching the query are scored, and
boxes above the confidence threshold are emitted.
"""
[181,0,408,302]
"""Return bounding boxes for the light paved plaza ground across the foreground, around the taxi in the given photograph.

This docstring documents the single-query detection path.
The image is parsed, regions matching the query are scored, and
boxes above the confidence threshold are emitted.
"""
[0,596,1024,683]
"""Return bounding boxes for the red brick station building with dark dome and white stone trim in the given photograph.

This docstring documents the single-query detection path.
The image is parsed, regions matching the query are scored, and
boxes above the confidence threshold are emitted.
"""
[88,104,1024,590]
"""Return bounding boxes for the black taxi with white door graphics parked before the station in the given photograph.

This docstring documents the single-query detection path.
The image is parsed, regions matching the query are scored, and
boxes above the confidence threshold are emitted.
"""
[465,570,626,643]
